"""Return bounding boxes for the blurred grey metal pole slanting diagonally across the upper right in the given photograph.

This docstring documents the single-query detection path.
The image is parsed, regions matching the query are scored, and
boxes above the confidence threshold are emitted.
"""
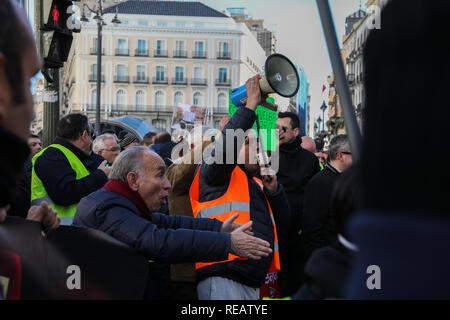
[316,0,361,161]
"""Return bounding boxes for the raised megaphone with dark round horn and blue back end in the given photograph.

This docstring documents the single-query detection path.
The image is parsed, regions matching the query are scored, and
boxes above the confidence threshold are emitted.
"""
[231,53,300,111]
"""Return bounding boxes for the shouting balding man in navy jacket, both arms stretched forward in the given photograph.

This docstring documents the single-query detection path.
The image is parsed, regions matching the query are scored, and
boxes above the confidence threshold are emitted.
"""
[73,146,272,298]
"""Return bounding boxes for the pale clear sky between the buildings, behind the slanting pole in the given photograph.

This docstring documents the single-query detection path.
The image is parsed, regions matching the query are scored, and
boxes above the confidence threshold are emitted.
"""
[202,0,366,135]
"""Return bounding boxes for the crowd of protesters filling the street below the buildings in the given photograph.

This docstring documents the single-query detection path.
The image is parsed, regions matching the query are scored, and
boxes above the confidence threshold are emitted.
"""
[0,0,450,300]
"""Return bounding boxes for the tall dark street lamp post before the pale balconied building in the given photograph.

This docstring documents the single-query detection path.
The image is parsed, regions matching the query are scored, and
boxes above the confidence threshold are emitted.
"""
[81,0,120,136]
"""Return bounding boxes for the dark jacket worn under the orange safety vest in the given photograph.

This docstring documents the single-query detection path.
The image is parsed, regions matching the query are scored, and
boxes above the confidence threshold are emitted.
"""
[196,107,289,288]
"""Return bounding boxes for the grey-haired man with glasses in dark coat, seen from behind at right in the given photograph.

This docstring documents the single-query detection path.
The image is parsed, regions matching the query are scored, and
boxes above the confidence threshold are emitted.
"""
[303,134,352,258]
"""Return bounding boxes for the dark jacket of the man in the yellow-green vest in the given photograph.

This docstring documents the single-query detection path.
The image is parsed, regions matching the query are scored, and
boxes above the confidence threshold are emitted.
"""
[34,138,108,206]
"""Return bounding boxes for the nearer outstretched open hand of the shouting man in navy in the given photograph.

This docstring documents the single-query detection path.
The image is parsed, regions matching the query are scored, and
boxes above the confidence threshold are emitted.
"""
[230,221,272,260]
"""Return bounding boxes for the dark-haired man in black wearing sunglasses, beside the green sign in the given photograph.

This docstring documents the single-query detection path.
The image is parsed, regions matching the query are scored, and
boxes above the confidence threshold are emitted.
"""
[277,112,320,296]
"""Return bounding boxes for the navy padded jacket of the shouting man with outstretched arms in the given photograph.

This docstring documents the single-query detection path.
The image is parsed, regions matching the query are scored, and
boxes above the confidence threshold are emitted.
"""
[73,189,230,263]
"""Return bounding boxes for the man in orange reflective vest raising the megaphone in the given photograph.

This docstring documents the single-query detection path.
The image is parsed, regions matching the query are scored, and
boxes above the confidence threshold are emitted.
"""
[190,76,289,300]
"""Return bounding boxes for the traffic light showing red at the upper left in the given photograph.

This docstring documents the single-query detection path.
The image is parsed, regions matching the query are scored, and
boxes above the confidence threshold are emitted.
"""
[42,0,81,69]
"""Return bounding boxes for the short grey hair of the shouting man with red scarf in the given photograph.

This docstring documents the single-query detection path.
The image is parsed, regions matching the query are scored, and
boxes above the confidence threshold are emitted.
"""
[109,146,150,182]
